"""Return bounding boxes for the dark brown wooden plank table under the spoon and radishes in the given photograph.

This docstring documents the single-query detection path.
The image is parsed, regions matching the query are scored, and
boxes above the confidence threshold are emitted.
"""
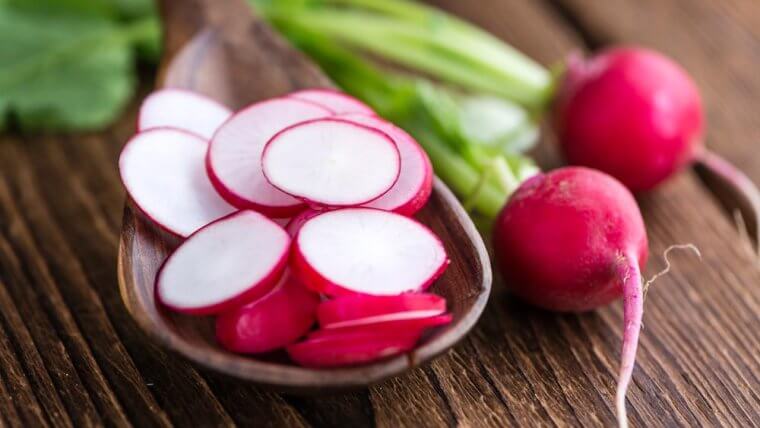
[0,0,760,427]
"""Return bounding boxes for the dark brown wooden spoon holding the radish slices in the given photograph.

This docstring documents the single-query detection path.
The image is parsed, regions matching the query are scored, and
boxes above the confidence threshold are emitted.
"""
[118,0,492,392]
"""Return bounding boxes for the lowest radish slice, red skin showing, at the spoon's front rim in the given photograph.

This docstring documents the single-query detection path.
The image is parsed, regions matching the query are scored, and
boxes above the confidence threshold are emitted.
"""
[287,334,419,367]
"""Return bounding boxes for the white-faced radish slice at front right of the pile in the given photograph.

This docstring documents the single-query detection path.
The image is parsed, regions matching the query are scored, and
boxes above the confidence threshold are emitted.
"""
[292,208,449,296]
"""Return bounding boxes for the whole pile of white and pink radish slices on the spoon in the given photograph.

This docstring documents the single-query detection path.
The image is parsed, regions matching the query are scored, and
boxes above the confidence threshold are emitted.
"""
[119,89,452,367]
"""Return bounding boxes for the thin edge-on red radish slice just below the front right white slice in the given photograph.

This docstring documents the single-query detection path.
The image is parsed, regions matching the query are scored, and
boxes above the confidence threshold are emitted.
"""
[317,293,446,328]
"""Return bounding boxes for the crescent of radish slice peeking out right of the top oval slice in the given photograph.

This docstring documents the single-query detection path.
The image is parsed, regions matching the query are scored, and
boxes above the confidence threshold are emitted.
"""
[341,114,433,216]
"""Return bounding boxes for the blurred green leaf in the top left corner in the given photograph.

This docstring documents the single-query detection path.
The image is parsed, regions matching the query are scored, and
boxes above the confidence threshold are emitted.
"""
[0,7,141,130]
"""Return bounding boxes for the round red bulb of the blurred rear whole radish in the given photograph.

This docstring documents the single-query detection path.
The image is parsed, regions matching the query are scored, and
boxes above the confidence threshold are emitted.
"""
[555,47,704,192]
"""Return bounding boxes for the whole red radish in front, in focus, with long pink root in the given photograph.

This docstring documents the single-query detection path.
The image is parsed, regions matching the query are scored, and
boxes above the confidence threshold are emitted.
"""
[493,167,648,425]
